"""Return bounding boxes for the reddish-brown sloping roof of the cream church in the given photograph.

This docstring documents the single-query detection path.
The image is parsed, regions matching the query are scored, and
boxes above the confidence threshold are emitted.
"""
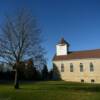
[53,49,100,61]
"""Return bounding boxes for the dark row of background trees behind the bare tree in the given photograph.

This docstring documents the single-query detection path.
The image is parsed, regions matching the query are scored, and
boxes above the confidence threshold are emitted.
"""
[0,59,53,81]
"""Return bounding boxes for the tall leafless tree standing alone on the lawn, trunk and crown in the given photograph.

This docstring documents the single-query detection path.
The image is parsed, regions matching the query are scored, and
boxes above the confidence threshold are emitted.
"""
[0,10,44,89]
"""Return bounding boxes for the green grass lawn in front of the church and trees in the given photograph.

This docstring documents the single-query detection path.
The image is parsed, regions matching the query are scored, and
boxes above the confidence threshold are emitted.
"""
[0,81,100,100]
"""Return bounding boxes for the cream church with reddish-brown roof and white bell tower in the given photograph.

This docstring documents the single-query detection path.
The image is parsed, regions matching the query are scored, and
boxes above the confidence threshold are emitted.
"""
[53,38,100,83]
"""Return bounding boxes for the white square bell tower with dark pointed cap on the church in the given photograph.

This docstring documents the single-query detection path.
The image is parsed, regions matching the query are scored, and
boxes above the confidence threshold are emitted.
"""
[56,38,69,56]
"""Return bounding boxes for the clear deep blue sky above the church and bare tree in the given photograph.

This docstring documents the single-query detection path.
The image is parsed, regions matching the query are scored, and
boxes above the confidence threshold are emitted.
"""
[0,0,100,68]
